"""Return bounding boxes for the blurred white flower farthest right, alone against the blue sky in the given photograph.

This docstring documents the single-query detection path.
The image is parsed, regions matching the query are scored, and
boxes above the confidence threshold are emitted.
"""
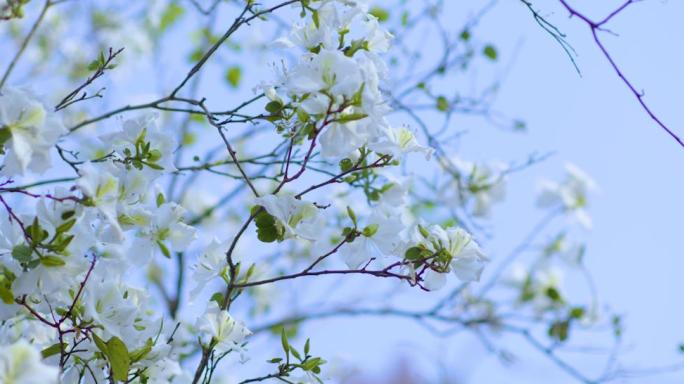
[537,164,597,229]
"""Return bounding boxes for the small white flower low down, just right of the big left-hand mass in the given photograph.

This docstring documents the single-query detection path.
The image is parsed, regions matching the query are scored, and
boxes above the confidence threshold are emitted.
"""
[197,302,252,353]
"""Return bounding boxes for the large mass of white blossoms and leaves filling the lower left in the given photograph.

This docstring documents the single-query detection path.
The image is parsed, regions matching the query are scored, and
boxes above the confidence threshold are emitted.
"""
[0,112,202,383]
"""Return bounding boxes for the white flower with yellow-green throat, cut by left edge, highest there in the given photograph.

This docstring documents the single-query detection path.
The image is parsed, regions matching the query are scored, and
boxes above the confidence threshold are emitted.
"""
[0,87,66,176]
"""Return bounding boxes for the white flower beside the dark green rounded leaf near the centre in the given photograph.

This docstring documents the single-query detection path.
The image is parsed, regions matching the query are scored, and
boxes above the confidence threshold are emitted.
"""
[255,194,323,240]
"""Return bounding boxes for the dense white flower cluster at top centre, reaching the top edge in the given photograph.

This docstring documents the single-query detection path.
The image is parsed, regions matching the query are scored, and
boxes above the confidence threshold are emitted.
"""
[262,1,432,159]
